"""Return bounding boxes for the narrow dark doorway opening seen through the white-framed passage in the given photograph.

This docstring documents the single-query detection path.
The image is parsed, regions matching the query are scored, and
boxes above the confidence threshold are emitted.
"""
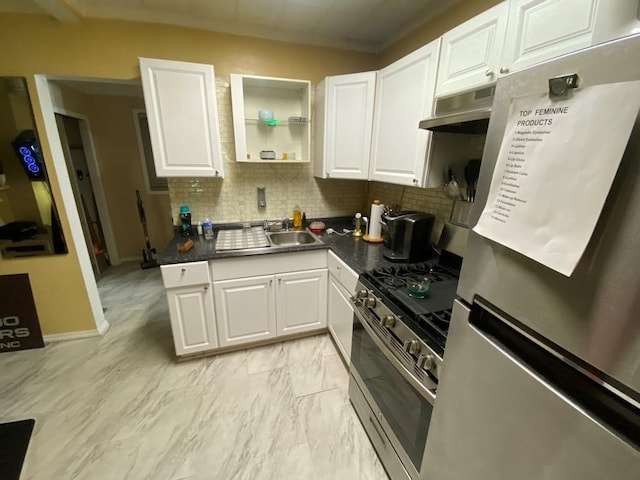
[55,113,111,280]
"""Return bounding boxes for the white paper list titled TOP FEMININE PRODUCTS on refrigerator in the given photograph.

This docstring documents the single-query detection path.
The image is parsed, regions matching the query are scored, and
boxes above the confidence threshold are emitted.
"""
[473,81,640,277]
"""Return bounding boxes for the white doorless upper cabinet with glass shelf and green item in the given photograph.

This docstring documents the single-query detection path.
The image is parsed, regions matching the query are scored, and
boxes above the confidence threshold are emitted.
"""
[230,73,311,163]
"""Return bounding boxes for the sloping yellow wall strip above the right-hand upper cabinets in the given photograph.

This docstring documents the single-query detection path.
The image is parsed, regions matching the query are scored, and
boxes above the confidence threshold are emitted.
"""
[378,0,503,68]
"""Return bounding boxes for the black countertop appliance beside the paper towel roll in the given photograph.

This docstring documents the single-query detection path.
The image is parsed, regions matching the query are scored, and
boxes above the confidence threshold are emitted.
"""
[380,212,435,262]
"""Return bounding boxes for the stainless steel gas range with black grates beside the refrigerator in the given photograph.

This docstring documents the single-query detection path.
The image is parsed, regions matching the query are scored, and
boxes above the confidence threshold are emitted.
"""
[349,225,467,480]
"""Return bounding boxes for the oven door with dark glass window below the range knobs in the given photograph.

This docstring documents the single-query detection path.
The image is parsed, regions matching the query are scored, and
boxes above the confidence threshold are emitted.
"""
[351,305,436,479]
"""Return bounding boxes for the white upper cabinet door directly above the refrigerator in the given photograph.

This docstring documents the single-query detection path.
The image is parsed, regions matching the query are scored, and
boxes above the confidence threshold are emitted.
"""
[500,0,638,73]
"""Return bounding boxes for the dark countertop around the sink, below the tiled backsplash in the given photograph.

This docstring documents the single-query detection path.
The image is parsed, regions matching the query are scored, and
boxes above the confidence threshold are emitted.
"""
[157,218,391,274]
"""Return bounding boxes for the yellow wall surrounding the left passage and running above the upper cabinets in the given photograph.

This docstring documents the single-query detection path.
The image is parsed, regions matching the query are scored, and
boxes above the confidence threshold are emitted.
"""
[0,14,377,334]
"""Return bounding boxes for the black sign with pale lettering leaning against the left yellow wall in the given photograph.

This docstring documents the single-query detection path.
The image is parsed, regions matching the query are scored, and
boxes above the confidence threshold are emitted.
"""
[0,273,44,353]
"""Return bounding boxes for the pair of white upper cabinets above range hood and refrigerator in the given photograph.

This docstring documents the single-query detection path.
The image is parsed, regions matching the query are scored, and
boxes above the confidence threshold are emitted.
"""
[436,0,640,97]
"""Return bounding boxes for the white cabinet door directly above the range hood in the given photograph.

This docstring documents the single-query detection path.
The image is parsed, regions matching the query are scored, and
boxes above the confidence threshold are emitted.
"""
[436,2,508,97]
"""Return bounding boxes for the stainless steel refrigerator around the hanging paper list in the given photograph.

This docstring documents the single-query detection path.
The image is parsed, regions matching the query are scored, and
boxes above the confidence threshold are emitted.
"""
[423,36,640,480]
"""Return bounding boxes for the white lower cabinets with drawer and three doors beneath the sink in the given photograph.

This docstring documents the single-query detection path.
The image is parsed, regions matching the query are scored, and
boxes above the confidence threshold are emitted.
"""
[161,250,330,356]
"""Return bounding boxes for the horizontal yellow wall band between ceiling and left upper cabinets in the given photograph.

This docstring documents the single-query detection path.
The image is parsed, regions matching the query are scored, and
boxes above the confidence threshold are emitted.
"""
[0,14,376,82]
